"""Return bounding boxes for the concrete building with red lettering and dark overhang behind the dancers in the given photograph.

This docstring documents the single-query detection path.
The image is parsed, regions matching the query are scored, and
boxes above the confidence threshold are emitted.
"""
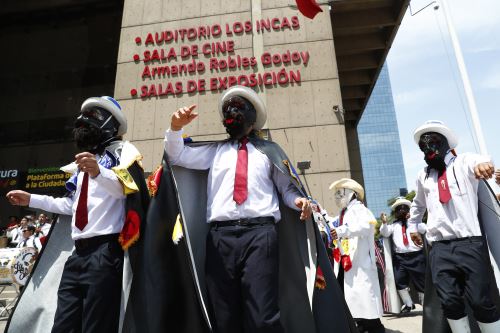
[0,0,408,223]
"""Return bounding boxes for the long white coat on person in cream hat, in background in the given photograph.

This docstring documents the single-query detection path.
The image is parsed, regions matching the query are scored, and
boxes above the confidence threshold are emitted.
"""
[335,200,384,319]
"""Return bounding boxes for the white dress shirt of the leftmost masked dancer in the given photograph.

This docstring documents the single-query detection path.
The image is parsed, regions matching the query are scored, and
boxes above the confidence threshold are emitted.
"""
[29,161,125,240]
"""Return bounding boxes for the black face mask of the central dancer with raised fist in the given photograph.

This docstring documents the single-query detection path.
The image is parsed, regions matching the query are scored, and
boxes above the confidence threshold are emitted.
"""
[222,96,257,140]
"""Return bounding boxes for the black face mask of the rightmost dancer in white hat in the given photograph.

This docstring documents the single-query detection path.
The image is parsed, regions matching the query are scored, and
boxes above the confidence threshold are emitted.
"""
[418,132,450,171]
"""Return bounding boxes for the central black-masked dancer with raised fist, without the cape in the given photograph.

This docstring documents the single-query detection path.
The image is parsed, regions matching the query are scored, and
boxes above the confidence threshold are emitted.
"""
[165,86,312,333]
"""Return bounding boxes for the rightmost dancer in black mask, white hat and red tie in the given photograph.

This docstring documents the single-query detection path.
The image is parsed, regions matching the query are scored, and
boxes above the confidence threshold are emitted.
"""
[408,121,500,333]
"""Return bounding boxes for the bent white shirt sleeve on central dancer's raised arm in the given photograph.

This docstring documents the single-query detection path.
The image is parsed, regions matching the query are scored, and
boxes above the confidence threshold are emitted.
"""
[165,129,217,170]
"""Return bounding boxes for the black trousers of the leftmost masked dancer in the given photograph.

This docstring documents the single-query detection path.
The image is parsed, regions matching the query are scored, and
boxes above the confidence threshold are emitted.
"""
[52,236,123,333]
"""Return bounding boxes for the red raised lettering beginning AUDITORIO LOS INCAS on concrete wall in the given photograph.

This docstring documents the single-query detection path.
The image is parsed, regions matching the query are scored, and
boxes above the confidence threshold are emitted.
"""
[130,16,310,99]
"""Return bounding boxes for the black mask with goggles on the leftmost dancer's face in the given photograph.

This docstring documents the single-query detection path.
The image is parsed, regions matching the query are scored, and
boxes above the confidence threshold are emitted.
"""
[73,107,119,154]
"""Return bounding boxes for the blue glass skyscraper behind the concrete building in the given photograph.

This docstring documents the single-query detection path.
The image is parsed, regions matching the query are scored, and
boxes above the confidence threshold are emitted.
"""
[357,64,407,217]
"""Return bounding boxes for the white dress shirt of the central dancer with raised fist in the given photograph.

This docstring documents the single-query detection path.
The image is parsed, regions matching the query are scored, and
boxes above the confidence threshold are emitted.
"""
[165,129,301,223]
